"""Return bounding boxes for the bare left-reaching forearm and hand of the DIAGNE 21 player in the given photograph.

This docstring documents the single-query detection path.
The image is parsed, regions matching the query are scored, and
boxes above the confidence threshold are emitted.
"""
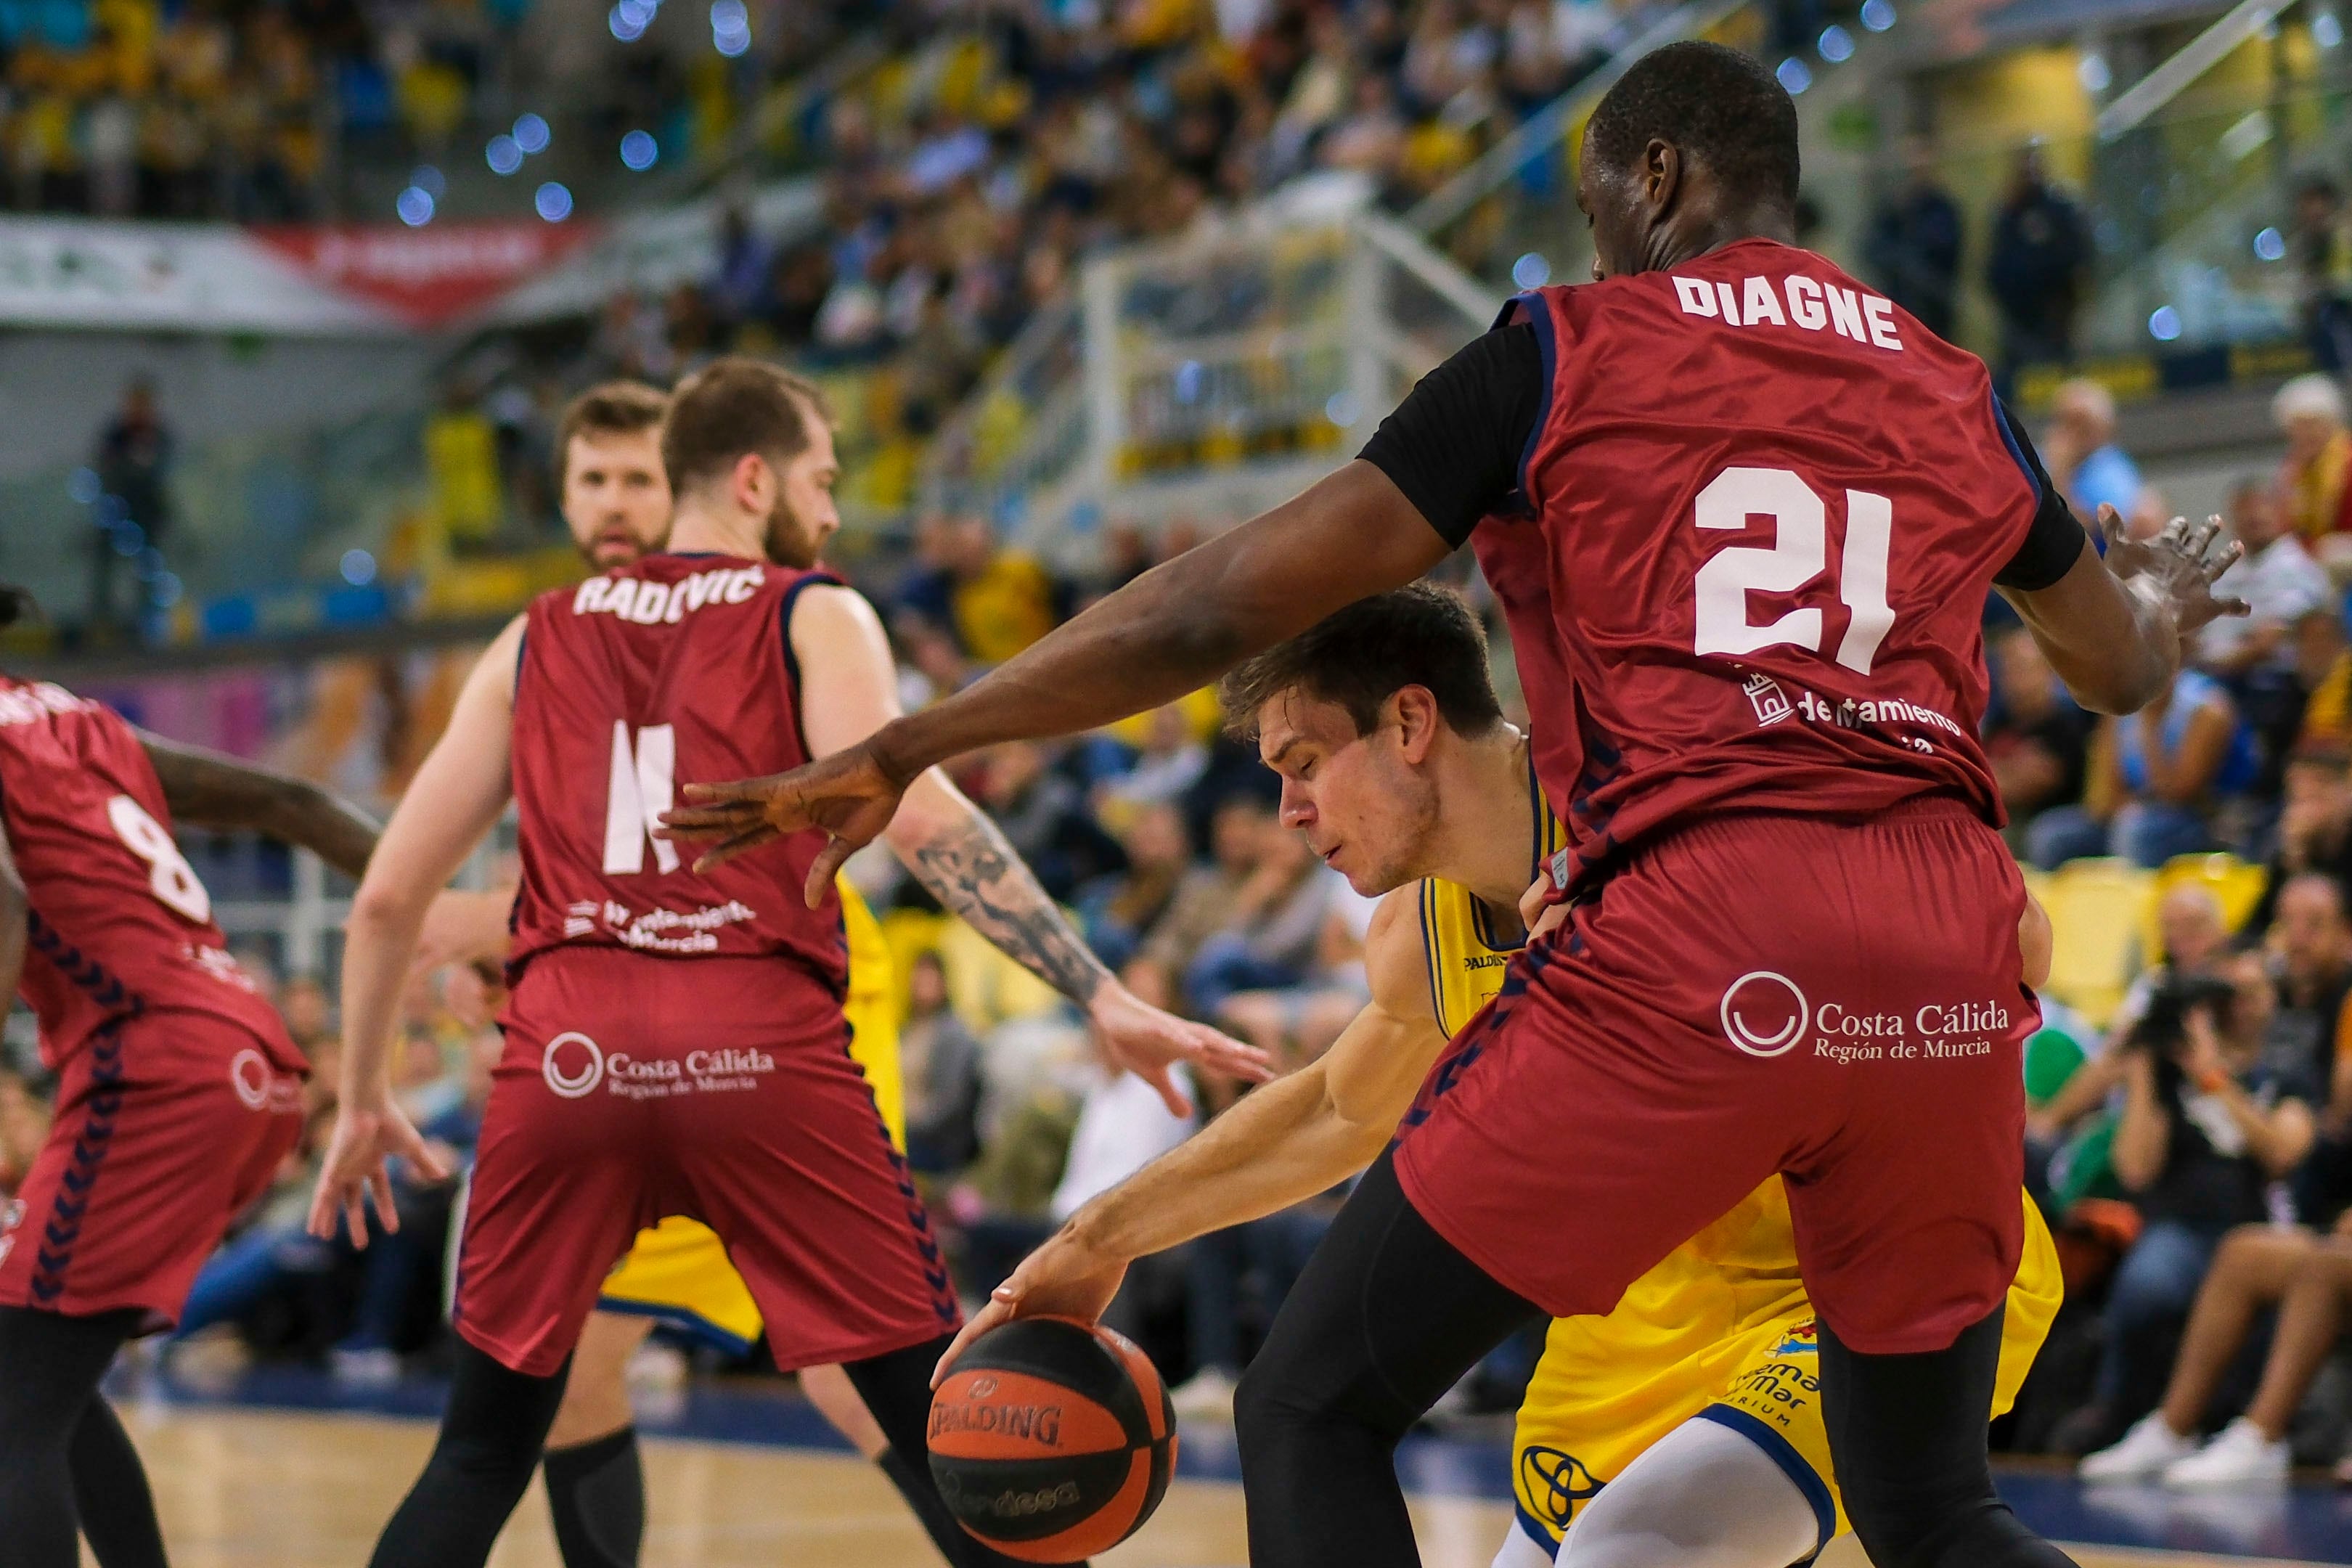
[668,458,1449,883]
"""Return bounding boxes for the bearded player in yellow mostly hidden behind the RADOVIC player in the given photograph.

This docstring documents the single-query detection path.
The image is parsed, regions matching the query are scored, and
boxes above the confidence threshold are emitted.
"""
[416,381,964,1568]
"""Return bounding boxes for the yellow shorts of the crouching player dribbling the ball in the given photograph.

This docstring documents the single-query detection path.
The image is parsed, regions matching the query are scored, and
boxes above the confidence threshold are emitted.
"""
[1512,1201,2062,1556]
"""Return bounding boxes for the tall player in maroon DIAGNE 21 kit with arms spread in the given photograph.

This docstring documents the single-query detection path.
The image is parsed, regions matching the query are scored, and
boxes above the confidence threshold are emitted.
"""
[670,45,2232,1568]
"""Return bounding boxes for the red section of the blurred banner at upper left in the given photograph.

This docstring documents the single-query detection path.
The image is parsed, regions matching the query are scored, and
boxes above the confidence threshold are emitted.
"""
[247,224,600,327]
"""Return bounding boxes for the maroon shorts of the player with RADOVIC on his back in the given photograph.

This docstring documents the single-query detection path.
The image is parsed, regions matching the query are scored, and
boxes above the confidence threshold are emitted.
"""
[454,947,962,1378]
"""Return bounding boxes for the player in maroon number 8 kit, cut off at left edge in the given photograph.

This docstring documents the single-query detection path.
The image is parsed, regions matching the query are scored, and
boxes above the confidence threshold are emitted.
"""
[0,588,376,1568]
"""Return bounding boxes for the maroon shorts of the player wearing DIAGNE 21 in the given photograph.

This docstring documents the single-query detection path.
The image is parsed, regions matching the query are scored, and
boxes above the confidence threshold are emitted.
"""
[1397,801,2039,1354]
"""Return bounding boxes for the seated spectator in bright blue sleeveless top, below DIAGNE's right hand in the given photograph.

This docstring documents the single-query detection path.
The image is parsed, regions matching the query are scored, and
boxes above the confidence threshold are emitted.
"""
[2035,670,2261,867]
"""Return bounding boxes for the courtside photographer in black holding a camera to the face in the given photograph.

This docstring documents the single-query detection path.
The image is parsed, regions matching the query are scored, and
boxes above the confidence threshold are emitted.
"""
[2084,980,2312,1477]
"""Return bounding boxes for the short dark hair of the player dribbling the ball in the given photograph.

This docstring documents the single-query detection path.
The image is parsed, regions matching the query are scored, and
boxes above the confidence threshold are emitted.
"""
[1216,583,1503,738]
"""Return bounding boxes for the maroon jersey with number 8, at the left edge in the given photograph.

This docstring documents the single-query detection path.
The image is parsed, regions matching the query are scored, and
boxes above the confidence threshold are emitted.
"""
[0,674,303,1072]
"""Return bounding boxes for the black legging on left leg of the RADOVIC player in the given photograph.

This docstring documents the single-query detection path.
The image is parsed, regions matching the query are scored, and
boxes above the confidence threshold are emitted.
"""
[367,1340,571,1568]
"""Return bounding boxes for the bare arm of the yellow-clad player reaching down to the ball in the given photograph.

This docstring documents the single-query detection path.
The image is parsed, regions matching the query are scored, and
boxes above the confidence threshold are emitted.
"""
[939,889,1447,1371]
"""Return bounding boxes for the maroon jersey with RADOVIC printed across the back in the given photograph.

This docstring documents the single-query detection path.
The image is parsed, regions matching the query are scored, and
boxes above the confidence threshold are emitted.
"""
[513,555,846,992]
